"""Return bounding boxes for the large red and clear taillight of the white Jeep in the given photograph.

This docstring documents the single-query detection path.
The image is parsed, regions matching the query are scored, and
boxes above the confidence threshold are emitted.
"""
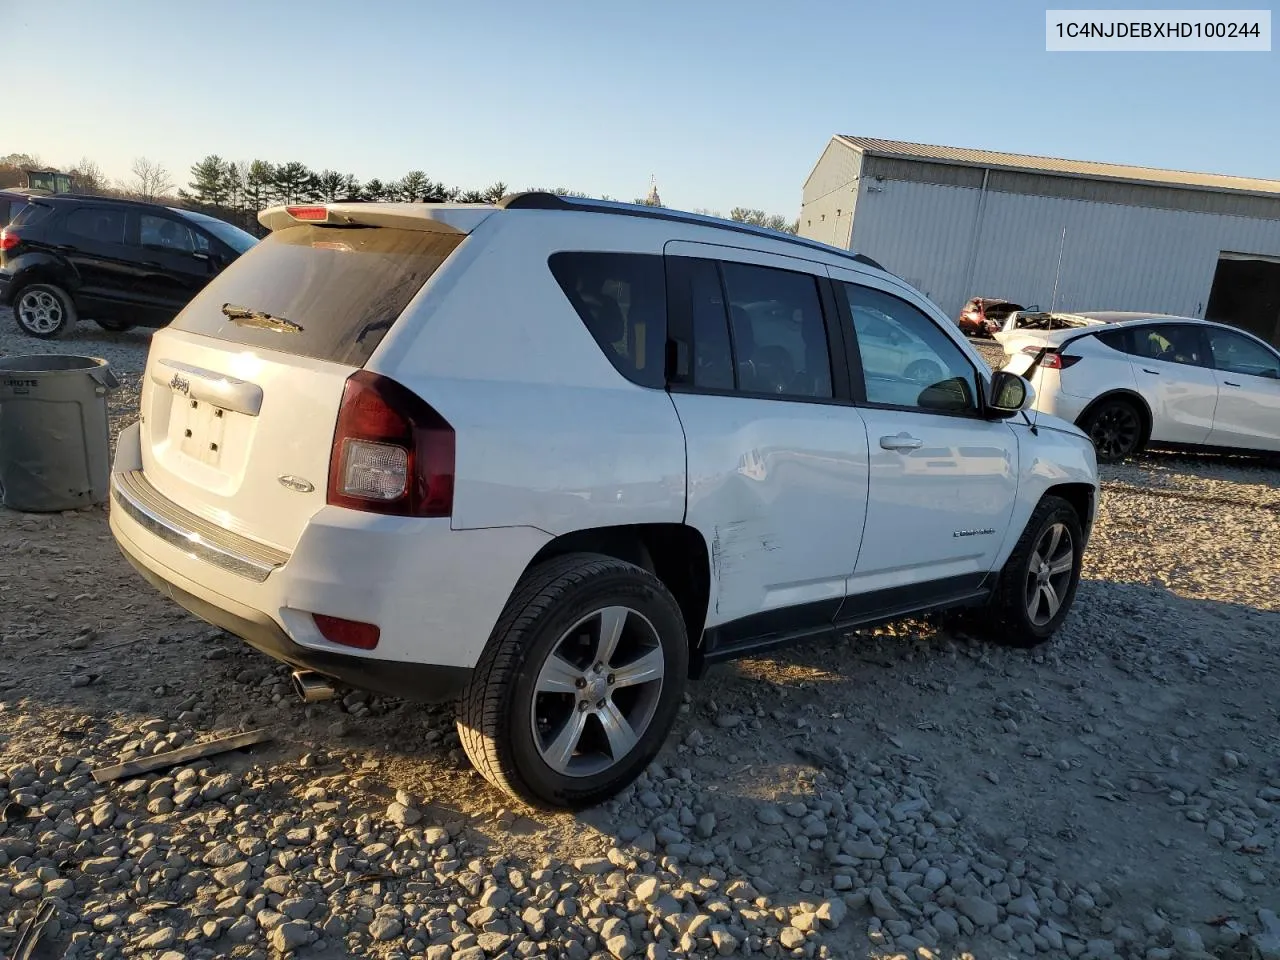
[326,370,454,517]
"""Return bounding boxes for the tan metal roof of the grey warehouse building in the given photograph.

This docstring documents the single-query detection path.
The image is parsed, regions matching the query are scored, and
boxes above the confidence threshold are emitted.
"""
[836,134,1280,196]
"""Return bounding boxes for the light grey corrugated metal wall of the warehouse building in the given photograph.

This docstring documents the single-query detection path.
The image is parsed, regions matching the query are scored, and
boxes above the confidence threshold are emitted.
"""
[844,178,1280,316]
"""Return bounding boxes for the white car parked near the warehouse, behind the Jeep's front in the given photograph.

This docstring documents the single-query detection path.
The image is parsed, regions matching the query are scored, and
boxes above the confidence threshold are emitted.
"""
[997,312,1280,462]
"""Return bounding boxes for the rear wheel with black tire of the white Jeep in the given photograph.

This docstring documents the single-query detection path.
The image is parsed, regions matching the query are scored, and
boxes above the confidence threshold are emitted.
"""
[457,553,689,809]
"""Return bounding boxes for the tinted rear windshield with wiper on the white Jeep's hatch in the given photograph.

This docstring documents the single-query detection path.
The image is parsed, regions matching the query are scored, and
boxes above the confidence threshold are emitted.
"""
[172,224,465,366]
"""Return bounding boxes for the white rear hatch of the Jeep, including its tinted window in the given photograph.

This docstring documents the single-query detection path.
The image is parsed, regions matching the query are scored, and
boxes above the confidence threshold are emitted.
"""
[141,205,483,552]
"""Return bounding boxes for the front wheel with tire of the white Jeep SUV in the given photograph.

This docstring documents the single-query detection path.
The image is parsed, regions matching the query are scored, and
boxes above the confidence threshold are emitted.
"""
[974,495,1084,648]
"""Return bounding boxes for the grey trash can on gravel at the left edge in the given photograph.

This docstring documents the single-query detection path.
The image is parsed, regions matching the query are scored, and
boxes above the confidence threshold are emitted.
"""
[0,353,119,513]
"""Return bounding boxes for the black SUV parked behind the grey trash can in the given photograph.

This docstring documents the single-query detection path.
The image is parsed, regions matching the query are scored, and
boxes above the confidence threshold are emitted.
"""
[0,195,257,339]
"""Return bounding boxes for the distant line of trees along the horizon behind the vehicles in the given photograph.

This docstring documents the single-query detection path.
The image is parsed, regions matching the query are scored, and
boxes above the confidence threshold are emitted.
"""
[0,154,799,234]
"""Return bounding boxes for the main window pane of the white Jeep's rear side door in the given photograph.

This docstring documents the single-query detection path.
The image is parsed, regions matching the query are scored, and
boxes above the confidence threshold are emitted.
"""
[721,262,832,399]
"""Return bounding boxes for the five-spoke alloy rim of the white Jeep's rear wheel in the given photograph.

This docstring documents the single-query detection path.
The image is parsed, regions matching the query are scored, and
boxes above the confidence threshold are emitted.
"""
[530,607,666,777]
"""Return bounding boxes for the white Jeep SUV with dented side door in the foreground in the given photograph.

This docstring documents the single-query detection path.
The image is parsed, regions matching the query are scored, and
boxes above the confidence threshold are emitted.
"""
[111,193,1098,808]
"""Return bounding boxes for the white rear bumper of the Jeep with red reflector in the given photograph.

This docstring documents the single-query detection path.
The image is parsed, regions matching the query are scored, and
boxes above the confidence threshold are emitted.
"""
[110,425,549,700]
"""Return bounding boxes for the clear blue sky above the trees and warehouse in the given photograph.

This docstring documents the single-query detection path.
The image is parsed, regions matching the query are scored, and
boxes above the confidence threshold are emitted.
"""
[0,0,1280,216]
